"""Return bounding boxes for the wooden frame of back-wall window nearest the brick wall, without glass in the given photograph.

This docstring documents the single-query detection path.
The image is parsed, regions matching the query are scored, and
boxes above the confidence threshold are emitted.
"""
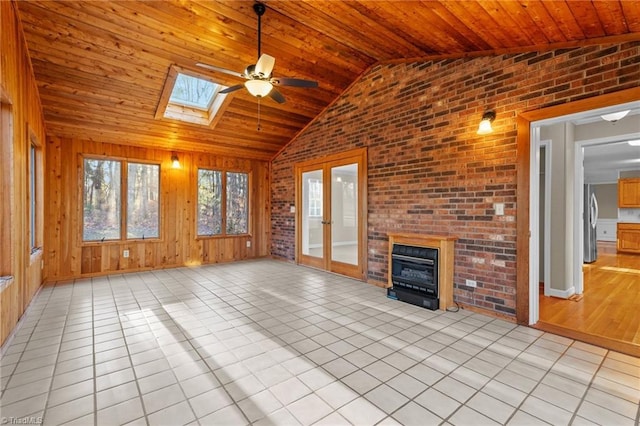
[194,166,253,240]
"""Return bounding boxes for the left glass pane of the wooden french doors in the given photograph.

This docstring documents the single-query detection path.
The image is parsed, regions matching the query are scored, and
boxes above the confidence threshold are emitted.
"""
[302,170,324,258]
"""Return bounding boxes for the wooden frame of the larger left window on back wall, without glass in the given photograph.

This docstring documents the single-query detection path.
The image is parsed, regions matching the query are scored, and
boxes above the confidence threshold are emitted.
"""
[78,154,164,247]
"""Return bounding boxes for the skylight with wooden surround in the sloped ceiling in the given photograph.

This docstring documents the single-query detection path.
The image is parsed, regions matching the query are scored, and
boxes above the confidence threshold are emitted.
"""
[156,66,227,126]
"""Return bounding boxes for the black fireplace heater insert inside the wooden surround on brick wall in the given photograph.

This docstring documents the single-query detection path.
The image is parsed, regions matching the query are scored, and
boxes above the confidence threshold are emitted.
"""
[387,244,440,310]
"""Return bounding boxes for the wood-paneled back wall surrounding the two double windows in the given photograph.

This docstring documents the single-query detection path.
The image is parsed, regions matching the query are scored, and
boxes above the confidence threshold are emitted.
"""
[45,136,271,281]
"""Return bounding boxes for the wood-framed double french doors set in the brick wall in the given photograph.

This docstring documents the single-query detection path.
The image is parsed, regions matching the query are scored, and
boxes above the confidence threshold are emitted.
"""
[295,149,367,280]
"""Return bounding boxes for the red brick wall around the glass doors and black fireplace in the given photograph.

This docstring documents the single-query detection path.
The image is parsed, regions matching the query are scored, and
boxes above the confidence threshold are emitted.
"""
[271,42,640,316]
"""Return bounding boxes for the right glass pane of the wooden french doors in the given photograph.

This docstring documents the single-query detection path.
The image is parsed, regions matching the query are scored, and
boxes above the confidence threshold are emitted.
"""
[331,163,358,265]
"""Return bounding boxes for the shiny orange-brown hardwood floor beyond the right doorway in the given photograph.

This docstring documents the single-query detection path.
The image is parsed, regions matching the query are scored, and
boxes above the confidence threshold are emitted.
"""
[535,244,640,357]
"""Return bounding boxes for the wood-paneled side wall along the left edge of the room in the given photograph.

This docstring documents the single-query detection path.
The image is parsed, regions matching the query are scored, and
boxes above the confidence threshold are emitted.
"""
[0,1,45,343]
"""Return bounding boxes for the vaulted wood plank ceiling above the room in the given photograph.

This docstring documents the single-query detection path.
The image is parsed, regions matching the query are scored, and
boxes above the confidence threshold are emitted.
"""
[16,0,640,159]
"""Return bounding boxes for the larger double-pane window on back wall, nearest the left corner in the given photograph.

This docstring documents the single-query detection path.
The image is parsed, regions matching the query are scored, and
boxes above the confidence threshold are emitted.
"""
[82,158,160,241]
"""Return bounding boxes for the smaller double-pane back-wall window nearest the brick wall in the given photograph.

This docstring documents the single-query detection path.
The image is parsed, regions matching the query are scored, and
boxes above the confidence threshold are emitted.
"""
[197,169,249,236]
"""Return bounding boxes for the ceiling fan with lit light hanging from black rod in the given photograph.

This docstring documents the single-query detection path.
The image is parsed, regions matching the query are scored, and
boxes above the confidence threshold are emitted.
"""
[196,3,318,104]
